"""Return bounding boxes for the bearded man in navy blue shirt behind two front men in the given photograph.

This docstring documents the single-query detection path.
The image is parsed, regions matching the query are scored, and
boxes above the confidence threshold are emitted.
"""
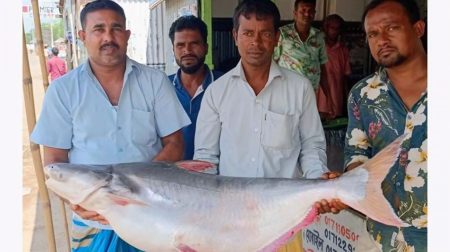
[169,16,222,160]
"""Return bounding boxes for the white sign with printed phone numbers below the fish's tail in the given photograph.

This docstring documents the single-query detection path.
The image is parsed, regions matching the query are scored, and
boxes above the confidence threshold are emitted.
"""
[301,210,380,252]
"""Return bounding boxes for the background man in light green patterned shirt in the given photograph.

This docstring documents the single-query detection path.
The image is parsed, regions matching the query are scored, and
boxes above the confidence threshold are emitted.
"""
[273,0,328,94]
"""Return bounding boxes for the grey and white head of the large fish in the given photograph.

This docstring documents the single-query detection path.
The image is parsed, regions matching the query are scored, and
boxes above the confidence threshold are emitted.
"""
[44,163,112,204]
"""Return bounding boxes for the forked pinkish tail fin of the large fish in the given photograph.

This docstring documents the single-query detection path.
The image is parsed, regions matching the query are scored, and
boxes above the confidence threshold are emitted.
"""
[342,135,410,227]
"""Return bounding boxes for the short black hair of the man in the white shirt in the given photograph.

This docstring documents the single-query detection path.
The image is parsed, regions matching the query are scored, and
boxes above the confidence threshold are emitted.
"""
[233,0,280,31]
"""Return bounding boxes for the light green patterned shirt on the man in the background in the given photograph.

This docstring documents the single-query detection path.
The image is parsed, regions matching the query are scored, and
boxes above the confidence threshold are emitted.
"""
[273,23,328,90]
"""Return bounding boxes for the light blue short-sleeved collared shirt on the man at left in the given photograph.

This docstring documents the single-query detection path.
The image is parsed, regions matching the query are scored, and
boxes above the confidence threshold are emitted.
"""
[31,58,190,164]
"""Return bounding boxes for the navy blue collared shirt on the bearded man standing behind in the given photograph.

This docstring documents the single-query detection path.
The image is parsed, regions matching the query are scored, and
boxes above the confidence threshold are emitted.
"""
[169,64,223,160]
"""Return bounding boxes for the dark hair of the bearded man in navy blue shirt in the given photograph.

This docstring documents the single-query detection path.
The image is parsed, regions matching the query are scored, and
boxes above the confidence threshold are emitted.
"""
[169,15,208,45]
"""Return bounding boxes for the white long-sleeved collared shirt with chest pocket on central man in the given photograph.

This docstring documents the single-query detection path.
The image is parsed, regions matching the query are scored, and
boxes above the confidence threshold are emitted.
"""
[194,62,328,178]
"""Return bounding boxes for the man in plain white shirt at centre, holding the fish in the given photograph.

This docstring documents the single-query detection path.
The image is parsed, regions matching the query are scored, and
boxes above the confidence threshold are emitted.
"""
[194,0,342,248]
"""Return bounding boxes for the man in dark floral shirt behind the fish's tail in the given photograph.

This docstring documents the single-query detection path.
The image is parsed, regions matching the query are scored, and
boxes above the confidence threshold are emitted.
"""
[345,0,428,251]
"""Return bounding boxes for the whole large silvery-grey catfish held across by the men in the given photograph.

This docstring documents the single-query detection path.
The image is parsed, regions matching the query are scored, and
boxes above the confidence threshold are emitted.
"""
[46,136,407,251]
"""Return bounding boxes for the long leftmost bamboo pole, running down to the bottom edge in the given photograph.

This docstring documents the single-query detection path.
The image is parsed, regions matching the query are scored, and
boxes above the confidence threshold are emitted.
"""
[22,27,56,252]
